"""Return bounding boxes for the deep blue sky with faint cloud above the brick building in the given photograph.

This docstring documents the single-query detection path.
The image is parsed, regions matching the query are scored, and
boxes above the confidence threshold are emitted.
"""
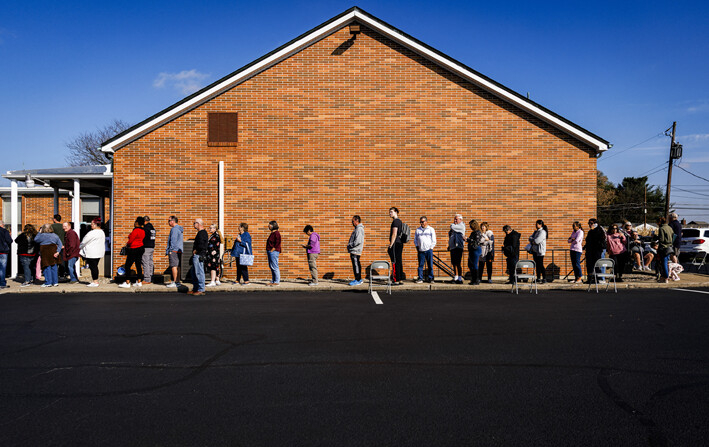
[0,0,709,221]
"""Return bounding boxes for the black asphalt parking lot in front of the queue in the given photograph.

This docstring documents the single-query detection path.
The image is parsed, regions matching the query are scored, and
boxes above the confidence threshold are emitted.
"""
[0,289,709,446]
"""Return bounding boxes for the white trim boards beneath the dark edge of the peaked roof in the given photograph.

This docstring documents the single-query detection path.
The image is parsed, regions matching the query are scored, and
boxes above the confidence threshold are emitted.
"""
[101,9,609,153]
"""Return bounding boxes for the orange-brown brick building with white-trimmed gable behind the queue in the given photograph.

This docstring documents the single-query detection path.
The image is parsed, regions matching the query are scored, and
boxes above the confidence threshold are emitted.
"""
[102,8,609,278]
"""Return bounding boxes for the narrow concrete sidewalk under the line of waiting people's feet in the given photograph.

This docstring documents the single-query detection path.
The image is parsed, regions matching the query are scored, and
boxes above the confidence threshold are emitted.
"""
[0,272,709,294]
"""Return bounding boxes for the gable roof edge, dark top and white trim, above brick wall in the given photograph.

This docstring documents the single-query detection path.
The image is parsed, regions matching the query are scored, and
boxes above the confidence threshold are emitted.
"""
[101,6,611,153]
